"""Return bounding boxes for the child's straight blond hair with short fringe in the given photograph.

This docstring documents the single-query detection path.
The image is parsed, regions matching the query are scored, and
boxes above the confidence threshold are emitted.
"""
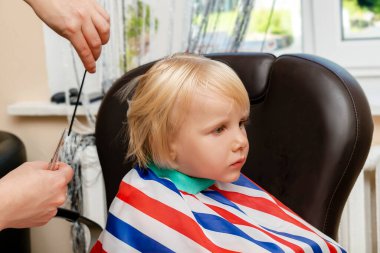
[122,54,250,167]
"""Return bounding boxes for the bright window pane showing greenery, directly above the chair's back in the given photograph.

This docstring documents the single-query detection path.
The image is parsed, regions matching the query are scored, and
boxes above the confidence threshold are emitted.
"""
[187,0,302,53]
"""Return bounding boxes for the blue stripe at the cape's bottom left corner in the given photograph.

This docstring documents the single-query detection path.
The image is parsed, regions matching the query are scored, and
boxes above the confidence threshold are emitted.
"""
[106,213,174,252]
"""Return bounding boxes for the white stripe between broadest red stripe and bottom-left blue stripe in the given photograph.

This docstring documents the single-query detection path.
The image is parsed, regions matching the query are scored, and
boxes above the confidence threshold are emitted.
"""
[110,199,209,252]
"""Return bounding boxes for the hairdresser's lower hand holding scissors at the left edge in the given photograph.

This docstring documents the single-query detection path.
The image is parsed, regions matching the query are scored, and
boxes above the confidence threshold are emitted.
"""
[0,162,73,230]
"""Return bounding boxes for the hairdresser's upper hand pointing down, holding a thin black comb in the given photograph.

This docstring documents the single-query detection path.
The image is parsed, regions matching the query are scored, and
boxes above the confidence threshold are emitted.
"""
[25,0,110,73]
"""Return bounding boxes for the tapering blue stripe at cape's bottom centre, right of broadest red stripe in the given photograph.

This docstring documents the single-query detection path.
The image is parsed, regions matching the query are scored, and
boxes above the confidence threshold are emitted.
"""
[193,212,284,252]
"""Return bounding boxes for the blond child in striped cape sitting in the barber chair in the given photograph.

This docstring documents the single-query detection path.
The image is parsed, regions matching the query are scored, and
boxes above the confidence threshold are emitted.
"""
[92,54,345,252]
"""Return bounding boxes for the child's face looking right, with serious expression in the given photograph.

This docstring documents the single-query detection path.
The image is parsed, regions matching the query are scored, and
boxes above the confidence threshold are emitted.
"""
[171,91,249,182]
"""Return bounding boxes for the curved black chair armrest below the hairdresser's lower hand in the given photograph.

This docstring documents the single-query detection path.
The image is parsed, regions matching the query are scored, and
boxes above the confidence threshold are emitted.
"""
[55,208,103,249]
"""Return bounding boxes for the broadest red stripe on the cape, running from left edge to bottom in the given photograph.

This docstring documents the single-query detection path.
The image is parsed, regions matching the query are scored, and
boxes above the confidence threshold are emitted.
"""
[117,182,236,252]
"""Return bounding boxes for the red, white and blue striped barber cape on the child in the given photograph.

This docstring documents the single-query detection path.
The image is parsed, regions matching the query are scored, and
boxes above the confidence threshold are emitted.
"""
[91,167,346,253]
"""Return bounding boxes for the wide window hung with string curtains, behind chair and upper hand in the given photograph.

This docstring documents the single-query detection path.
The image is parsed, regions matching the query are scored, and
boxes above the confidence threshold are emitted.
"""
[45,0,302,98]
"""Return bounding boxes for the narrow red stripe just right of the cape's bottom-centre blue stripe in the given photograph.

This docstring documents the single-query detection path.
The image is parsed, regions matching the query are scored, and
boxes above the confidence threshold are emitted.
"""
[206,204,304,252]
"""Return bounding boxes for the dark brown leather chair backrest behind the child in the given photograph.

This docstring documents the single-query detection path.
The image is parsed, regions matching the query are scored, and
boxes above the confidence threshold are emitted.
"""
[96,53,373,238]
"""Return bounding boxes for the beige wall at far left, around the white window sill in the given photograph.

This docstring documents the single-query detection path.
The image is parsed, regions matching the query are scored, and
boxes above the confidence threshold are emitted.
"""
[0,0,71,253]
